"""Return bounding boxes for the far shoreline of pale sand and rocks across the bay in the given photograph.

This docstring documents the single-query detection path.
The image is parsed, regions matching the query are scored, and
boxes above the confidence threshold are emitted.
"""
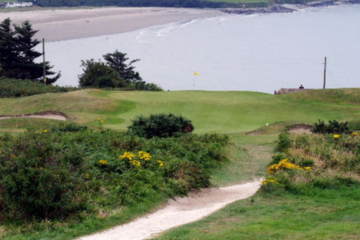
[0,0,360,42]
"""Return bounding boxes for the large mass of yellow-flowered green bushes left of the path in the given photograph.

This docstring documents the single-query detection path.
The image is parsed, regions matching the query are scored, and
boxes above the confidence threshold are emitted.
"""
[0,124,228,219]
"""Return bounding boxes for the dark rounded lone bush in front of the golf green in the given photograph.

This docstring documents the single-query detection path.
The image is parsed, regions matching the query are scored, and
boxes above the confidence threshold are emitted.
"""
[128,114,194,138]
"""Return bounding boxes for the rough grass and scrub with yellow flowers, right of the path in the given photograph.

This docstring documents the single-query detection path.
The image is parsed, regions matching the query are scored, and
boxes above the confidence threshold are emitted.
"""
[262,131,360,194]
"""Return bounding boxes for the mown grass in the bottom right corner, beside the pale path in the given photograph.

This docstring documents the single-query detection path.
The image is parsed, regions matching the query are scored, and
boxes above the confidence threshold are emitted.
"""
[156,186,360,240]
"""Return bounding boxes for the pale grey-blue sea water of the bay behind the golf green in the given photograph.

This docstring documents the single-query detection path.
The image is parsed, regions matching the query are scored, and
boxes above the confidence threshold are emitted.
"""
[47,5,360,93]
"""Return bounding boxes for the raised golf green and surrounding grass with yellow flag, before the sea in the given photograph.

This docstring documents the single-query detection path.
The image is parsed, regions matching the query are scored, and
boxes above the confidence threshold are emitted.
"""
[0,90,360,134]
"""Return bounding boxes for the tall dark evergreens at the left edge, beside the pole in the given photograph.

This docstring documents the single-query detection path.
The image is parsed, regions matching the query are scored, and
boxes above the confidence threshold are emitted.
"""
[0,19,60,84]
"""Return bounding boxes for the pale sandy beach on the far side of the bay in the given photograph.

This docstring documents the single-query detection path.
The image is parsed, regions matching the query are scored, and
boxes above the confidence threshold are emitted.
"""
[0,7,223,41]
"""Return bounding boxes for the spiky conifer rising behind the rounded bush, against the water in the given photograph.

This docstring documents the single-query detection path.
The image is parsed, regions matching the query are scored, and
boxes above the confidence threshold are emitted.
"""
[104,50,142,84]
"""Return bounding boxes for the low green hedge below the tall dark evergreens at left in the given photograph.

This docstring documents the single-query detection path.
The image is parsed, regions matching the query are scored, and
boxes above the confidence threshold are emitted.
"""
[0,78,75,98]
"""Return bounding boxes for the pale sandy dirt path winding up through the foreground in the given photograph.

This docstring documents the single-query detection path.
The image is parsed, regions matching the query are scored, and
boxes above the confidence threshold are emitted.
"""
[77,180,260,240]
